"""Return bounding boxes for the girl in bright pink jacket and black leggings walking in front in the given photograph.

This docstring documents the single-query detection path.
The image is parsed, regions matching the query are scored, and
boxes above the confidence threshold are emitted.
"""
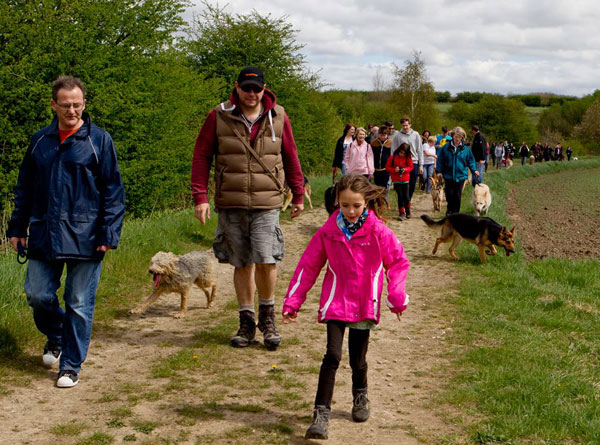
[282,175,410,439]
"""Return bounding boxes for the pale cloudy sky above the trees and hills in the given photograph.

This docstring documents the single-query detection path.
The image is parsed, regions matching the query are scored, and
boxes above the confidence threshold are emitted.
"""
[188,0,600,96]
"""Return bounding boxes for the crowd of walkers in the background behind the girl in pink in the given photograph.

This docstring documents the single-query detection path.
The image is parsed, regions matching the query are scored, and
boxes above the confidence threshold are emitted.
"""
[333,116,573,220]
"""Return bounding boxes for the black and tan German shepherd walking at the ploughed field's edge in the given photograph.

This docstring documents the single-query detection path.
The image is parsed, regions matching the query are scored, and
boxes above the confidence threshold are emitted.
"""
[421,213,515,264]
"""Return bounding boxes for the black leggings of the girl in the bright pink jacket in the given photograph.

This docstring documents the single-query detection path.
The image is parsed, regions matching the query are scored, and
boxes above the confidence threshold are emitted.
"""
[315,320,371,408]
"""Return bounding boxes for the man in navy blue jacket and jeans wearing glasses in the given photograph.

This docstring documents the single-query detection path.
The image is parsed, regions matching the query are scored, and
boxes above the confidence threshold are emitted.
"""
[7,76,125,388]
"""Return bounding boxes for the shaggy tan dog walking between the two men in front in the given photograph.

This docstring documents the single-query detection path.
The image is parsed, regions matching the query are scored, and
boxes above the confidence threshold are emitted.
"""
[129,252,217,318]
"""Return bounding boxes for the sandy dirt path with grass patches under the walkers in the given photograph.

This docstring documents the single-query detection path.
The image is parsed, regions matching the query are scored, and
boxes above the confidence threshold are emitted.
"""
[0,194,456,445]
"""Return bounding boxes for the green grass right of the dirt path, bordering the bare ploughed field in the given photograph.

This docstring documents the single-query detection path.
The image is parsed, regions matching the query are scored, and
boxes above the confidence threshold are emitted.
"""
[446,156,600,444]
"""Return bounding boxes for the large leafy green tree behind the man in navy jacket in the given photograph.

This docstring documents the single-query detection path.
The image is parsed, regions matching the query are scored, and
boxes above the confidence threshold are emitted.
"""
[0,0,220,219]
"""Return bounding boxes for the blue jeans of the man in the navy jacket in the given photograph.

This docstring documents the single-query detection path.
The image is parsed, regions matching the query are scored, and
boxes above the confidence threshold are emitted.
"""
[25,260,101,373]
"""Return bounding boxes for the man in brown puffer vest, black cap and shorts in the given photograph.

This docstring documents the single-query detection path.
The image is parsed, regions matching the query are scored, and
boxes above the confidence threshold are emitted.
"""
[192,67,304,349]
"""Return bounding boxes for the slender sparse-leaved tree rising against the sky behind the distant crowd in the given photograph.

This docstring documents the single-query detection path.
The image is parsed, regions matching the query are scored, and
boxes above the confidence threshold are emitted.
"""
[393,51,439,128]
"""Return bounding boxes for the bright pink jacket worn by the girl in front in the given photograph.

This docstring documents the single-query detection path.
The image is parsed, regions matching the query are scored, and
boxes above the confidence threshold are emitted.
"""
[282,209,410,323]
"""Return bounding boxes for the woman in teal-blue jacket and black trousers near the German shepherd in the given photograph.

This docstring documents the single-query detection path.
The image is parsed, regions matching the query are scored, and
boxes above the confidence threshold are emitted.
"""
[435,127,479,215]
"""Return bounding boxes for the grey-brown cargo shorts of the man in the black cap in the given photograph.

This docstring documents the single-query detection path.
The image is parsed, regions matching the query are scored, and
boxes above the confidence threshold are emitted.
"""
[213,209,284,267]
